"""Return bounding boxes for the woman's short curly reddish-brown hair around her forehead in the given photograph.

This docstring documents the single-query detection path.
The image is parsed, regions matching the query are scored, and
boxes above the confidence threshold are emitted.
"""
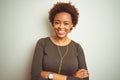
[49,2,79,27]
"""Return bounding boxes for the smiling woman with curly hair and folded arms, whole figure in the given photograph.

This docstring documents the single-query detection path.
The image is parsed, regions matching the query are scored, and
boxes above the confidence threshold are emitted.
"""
[31,2,89,80]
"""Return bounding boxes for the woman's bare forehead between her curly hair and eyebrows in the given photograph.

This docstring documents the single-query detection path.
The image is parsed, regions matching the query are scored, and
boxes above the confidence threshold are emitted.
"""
[54,12,72,21]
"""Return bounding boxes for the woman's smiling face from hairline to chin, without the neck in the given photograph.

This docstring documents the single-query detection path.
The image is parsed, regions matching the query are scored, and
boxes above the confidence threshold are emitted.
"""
[53,12,73,38]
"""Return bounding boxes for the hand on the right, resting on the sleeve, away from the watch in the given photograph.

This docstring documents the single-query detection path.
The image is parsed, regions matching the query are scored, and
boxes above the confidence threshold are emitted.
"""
[73,69,89,78]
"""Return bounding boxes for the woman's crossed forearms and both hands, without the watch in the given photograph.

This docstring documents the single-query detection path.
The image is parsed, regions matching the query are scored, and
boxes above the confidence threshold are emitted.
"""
[40,69,89,80]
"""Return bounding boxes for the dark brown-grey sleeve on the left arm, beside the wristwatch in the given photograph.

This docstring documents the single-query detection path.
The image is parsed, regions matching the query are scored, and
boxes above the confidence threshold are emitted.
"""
[31,39,45,80]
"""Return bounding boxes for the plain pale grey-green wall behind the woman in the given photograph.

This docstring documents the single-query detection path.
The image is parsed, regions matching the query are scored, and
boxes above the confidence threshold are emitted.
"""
[0,0,120,80]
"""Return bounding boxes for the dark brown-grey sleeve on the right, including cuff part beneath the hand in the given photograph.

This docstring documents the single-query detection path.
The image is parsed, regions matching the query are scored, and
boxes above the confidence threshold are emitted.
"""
[67,45,89,80]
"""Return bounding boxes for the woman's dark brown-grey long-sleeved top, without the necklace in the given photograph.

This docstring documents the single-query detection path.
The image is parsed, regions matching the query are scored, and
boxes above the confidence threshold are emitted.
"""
[31,37,89,80]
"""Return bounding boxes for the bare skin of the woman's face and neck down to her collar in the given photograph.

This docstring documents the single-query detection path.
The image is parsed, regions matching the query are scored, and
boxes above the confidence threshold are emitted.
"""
[51,12,73,46]
